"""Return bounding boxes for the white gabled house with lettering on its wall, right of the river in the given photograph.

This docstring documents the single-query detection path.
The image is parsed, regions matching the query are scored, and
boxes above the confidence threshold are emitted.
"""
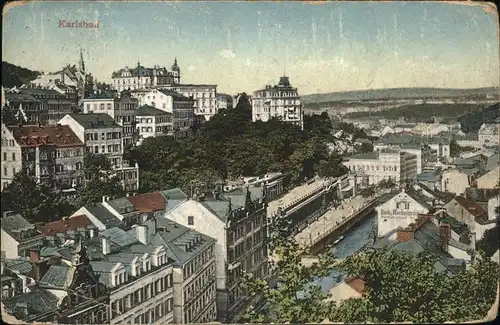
[375,190,430,237]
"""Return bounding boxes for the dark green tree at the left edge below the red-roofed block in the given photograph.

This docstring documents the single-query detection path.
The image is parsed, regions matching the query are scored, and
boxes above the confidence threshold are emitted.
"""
[1,172,60,222]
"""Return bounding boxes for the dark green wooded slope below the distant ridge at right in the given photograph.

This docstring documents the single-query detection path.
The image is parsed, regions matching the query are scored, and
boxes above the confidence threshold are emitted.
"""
[344,104,487,122]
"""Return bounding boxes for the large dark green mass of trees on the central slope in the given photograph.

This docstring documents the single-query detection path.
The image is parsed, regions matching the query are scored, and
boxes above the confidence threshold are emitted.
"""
[127,94,345,192]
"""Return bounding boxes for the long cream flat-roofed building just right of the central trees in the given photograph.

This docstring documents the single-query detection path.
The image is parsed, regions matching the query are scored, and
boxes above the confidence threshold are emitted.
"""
[344,150,417,185]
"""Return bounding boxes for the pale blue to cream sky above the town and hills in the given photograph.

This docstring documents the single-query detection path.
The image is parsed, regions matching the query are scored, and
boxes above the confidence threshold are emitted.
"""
[2,1,500,94]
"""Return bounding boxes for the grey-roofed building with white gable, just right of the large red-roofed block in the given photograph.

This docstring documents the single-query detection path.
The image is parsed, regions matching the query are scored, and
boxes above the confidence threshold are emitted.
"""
[60,113,139,191]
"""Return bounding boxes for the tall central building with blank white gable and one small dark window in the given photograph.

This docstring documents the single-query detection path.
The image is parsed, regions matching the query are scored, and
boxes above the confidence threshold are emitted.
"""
[164,186,268,322]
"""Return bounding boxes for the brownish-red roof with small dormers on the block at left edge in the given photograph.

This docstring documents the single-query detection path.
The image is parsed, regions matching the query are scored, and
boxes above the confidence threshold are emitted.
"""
[9,125,84,147]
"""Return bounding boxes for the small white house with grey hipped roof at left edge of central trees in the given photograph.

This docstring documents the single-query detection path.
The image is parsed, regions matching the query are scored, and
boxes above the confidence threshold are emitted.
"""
[136,105,174,144]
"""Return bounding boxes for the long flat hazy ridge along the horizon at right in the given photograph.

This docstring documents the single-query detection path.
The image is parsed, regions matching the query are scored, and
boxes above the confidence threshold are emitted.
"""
[302,87,500,105]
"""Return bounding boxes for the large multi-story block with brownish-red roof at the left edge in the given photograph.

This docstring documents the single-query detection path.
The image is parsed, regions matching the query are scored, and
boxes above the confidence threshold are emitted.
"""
[2,124,84,189]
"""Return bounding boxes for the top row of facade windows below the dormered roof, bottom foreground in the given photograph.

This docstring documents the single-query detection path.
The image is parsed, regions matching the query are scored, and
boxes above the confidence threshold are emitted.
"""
[111,274,173,318]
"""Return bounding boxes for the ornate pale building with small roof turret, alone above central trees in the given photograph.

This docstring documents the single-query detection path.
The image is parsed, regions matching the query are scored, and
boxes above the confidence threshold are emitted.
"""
[252,76,304,129]
